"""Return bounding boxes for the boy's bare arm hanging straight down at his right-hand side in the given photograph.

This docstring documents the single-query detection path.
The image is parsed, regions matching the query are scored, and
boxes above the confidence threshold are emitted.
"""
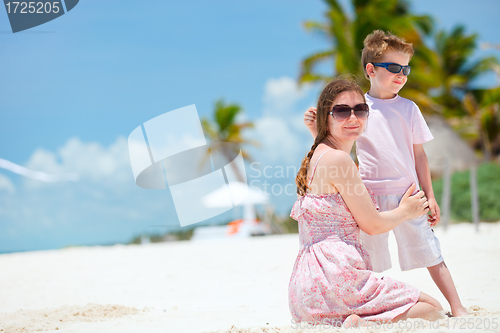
[413,144,441,226]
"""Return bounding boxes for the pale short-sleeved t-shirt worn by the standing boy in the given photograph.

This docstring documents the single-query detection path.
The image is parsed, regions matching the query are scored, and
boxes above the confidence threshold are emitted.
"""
[356,94,434,195]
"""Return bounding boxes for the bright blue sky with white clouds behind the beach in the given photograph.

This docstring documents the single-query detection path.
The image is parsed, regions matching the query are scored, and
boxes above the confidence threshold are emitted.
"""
[0,0,500,252]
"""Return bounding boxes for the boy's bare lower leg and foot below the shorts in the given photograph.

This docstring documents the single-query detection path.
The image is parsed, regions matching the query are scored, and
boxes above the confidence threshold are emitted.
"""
[427,261,468,317]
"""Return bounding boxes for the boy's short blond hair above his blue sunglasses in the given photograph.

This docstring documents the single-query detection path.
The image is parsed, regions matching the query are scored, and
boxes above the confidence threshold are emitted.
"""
[361,30,413,80]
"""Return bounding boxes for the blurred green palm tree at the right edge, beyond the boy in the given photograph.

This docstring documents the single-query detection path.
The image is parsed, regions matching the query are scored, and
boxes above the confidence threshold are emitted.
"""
[434,26,500,160]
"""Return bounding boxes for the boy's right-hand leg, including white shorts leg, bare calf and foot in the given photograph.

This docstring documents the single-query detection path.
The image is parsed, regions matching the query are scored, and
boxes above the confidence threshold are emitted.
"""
[394,201,467,316]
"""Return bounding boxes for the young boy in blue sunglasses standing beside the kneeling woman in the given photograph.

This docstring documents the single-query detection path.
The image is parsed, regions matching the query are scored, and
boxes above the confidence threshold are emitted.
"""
[304,30,467,316]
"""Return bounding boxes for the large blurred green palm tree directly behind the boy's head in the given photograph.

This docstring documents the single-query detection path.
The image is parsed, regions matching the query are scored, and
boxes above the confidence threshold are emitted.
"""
[299,0,436,108]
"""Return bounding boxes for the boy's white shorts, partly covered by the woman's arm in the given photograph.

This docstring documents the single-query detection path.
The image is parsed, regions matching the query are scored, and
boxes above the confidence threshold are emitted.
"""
[361,194,444,272]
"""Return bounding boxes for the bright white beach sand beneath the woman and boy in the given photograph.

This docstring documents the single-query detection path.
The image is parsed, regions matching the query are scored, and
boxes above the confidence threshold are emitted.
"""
[0,223,500,333]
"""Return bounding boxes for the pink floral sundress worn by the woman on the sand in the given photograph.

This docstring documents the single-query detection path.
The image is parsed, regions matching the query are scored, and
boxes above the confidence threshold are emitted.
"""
[288,151,420,324]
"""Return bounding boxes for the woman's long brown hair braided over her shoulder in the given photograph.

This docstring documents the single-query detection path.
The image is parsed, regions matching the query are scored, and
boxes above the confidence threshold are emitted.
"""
[295,78,365,196]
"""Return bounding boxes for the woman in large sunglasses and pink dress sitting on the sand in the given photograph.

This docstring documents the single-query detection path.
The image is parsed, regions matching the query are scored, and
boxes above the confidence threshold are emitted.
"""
[289,79,442,326]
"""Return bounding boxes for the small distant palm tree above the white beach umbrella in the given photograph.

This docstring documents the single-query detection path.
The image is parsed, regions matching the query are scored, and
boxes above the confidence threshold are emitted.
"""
[201,99,258,182]
